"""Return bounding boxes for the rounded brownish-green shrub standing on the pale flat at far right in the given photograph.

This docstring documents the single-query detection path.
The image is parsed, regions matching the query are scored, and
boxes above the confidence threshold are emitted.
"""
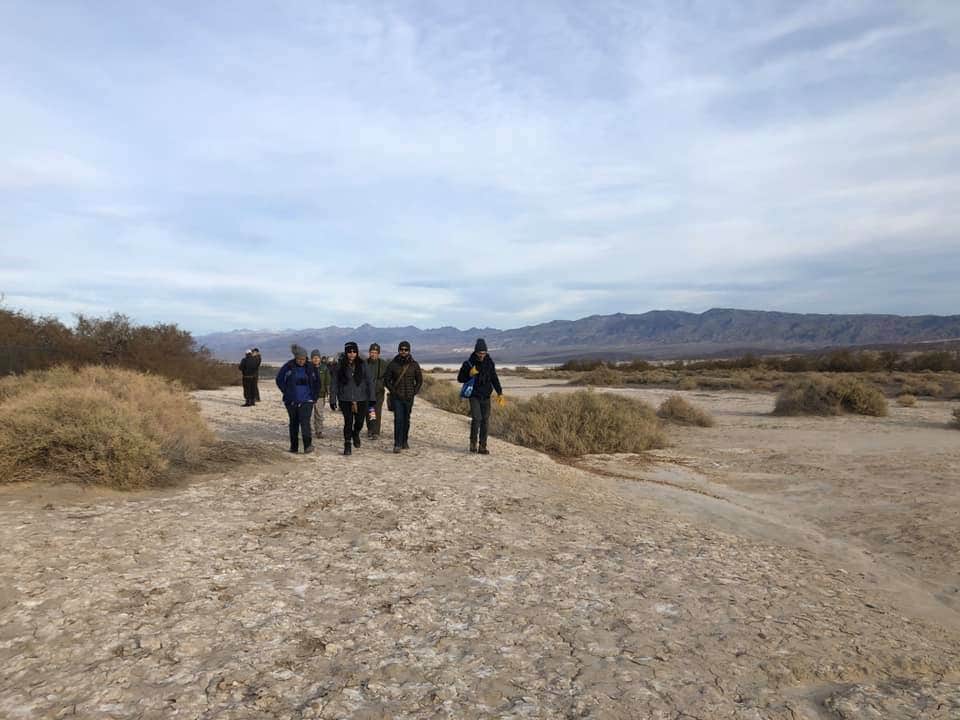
[773,377,887,416]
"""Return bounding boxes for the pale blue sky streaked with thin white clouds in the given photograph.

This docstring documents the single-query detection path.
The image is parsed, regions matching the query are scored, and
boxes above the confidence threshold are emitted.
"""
[0,0,960,332]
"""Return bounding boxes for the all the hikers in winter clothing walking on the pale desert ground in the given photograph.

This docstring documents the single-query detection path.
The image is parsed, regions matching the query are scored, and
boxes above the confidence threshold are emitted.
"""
[240,338,503,455]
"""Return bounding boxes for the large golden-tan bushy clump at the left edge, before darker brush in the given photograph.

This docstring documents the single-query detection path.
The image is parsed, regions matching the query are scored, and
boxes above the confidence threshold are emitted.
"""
[0,366,213,489]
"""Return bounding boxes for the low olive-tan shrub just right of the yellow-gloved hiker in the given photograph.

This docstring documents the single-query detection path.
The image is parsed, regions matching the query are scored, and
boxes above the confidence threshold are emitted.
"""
[490,390,666,457]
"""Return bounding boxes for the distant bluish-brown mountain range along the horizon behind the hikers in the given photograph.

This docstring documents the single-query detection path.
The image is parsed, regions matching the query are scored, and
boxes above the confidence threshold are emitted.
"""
[197,308,960,364]
